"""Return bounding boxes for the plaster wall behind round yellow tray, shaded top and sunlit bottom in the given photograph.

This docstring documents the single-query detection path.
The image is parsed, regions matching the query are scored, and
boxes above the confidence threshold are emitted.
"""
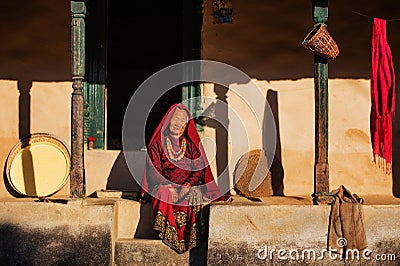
[0,0,72,198]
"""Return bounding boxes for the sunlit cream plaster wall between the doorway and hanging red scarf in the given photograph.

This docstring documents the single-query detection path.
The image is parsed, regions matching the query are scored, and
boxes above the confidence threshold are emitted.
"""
[204,78,392,195]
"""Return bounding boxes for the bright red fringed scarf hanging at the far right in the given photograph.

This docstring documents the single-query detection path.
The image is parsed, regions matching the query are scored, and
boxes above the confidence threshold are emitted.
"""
[370,18,396,173]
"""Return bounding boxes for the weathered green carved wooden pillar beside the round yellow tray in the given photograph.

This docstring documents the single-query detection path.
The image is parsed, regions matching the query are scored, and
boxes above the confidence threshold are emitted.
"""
[70,1,86,198]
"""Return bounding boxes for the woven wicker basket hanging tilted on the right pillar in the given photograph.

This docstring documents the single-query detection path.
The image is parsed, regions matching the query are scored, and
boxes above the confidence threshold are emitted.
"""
[302,24,339,60]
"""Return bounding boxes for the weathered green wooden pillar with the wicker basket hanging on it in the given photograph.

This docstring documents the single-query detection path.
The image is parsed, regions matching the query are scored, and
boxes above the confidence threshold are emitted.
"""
[312,0,329,203]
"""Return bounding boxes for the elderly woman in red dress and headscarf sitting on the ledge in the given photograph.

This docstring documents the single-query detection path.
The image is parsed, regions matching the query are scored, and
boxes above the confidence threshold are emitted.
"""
[139,104,221,253]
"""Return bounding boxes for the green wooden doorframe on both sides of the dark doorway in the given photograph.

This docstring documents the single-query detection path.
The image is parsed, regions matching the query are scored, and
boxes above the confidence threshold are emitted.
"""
[84,0,203,149]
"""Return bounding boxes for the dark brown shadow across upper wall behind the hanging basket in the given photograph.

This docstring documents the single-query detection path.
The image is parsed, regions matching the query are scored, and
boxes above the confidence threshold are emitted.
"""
[202,0,400,80]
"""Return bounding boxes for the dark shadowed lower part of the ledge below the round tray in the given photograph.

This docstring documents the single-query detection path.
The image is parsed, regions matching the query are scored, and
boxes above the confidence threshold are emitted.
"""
[0,224,111,265]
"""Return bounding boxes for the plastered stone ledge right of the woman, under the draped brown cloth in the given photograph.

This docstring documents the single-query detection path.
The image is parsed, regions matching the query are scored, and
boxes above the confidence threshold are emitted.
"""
[207,203,400,265]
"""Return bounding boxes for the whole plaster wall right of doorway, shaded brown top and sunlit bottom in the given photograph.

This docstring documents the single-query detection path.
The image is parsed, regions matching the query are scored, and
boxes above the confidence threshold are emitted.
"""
[201,0,400,196]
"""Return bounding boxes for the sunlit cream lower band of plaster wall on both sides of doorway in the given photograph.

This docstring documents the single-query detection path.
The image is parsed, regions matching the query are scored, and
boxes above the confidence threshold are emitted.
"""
[0,78,392,197]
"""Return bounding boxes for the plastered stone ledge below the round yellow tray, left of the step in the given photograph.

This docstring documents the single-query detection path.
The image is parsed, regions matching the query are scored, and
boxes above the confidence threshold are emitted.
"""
[0,201,115,265]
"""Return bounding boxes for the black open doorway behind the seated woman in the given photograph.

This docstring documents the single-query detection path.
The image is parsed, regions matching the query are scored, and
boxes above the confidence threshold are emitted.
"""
[106,0,202,149]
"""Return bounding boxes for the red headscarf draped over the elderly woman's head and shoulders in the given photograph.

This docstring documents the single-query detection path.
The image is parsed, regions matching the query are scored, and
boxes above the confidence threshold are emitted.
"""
[139,103,222,200]
